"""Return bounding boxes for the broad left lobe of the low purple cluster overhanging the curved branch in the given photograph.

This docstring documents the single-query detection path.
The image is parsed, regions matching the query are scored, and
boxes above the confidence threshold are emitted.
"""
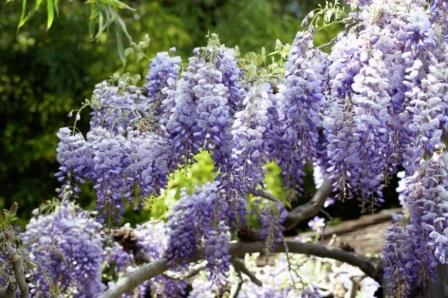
[166,182,228,265]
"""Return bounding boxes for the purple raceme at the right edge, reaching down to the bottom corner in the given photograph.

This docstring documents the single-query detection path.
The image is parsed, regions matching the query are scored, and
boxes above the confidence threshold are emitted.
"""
[383,152,448,297]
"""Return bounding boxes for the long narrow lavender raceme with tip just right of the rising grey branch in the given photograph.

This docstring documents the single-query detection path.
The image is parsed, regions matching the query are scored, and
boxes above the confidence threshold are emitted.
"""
[323,33,367,197]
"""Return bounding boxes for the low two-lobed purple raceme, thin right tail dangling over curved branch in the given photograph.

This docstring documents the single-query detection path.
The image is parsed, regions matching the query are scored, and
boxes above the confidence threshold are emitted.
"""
[166,182,230,279]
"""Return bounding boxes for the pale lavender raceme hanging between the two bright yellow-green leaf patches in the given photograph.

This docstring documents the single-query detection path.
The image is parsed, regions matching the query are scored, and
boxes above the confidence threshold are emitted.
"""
[230,82,281,194]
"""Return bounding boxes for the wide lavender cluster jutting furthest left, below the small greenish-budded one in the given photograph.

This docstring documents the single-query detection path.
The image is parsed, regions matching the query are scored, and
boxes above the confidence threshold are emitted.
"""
[57,127,170,218]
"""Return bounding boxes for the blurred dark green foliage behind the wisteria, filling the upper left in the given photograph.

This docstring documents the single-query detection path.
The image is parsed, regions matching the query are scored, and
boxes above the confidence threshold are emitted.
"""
[0,0,340,218]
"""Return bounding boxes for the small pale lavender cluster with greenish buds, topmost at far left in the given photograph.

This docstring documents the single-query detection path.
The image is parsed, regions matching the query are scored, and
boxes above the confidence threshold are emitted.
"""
[90,81,150,133]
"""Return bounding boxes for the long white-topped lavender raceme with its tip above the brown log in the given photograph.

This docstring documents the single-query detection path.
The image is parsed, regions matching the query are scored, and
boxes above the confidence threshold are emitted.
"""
[350,46,392,203]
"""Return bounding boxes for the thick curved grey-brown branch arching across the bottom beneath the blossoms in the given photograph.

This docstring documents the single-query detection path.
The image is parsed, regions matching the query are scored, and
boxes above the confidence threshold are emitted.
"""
[100,240,383,298]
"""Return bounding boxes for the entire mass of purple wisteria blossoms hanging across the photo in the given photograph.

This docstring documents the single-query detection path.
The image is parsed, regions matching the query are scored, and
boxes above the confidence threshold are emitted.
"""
[10,0,448,297]
